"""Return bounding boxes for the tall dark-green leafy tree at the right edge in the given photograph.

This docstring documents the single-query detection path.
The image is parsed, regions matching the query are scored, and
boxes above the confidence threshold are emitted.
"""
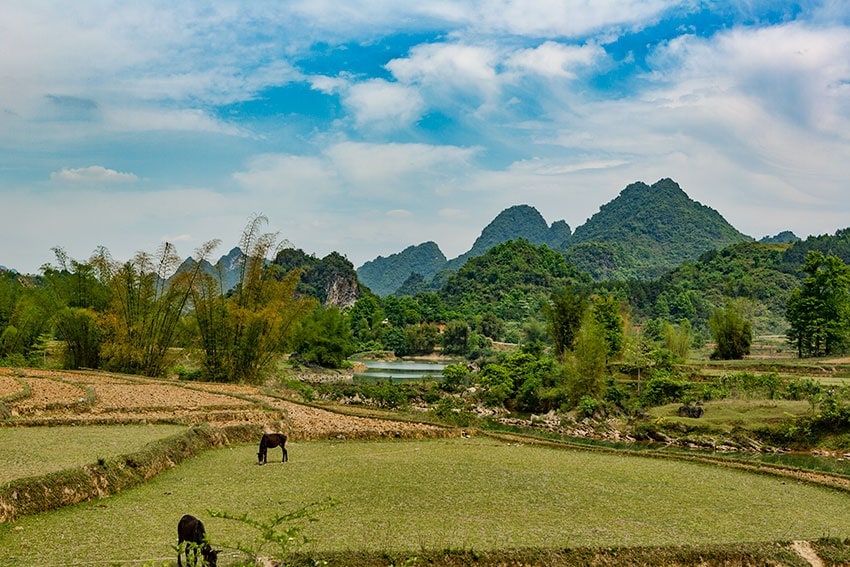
[785,250,850,358]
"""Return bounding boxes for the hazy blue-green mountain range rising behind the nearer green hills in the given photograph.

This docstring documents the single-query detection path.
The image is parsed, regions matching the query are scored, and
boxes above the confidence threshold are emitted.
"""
[357,179,752,295]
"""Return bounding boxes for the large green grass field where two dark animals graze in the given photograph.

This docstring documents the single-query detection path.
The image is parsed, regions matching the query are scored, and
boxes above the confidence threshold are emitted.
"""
[0,437,850,565]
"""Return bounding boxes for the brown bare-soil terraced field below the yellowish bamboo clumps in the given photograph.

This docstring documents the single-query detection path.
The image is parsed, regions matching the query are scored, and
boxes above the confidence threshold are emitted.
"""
[0,368,447,439]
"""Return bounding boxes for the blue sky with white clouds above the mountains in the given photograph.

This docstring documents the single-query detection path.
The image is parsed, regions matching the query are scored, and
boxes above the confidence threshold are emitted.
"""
[0,0,850,273]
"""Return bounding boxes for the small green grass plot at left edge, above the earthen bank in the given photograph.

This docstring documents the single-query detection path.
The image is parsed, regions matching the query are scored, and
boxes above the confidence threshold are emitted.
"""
[0,425,186,484]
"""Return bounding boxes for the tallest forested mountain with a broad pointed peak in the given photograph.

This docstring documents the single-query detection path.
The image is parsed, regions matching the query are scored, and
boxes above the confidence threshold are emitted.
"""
[566,179,752,280]
